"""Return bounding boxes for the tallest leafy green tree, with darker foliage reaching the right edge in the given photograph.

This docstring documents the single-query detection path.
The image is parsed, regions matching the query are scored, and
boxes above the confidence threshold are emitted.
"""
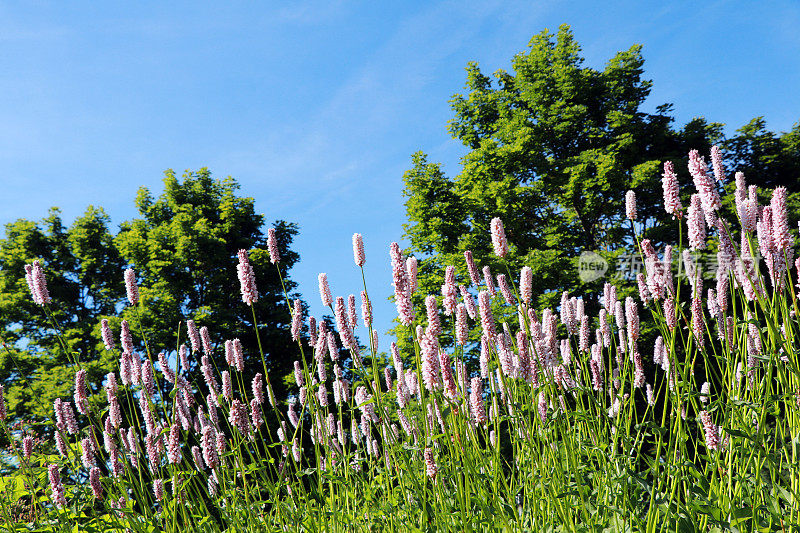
[403,25,800,358]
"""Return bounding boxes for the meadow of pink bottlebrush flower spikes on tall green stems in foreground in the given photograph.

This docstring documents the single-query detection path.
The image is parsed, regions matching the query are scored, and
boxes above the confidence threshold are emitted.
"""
[0,147,800,532]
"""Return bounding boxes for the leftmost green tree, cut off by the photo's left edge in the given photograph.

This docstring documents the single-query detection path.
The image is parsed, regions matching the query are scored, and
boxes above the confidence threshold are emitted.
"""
[0,206,124,418]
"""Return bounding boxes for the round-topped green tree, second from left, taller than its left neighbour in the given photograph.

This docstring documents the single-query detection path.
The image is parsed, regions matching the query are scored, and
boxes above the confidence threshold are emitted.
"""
[115,168,299,404]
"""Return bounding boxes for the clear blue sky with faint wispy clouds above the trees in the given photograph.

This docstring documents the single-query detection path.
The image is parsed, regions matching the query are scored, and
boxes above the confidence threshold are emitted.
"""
[0,0,800,348]
